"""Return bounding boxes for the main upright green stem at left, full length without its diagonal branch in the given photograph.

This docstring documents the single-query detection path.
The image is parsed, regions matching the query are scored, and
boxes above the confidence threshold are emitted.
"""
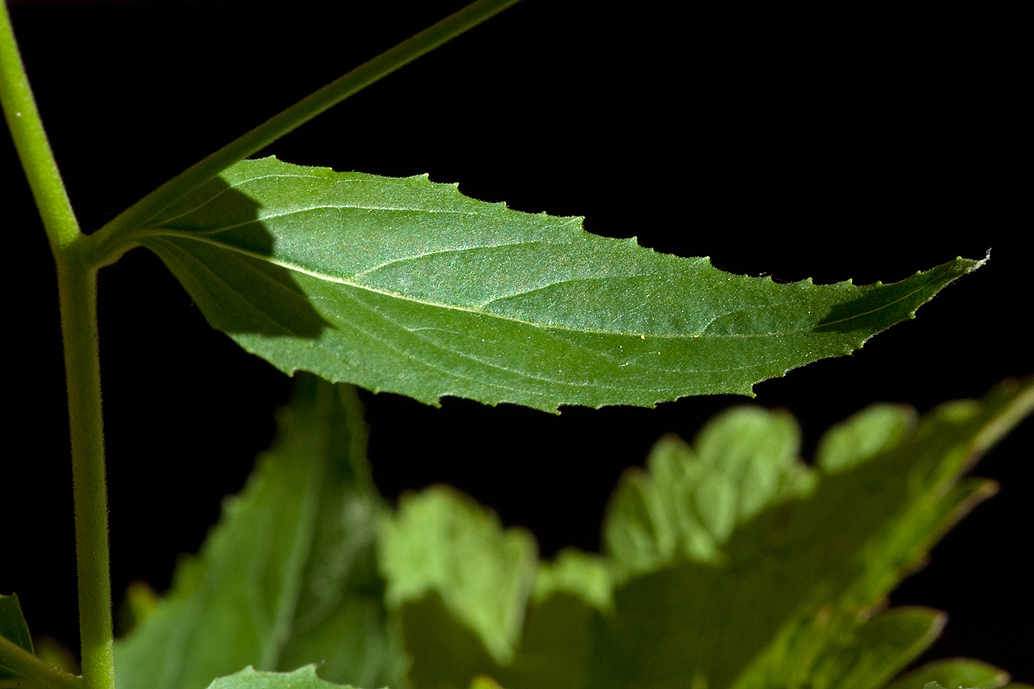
[0,0,115,689]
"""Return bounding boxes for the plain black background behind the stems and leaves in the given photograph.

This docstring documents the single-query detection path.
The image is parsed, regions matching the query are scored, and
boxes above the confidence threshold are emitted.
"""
[0,0,1034,682]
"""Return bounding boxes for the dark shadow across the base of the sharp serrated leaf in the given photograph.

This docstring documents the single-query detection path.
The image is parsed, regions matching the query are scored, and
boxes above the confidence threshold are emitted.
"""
[142,178,330,339]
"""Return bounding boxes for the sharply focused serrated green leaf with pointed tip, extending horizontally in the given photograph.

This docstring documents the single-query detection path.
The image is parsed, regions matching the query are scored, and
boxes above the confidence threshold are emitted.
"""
[125,158,983,411]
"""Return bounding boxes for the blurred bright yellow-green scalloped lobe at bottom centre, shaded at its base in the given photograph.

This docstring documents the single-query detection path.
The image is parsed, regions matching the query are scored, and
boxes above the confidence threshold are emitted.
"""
[379,487,536,689]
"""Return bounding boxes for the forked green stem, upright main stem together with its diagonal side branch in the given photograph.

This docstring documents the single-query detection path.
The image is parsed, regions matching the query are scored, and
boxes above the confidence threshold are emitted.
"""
[0,0,518,689]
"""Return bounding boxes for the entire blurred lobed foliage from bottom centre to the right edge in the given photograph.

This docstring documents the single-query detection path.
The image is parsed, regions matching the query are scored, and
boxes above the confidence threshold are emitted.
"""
[386,379,1034,689]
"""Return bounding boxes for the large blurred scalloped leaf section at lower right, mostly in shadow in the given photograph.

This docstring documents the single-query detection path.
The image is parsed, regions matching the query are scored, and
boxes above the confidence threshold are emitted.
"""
[590,380,1034,689]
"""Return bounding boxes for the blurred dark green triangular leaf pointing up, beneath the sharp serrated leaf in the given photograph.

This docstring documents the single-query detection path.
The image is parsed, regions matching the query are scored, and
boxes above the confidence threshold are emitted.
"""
[116,378,404,689]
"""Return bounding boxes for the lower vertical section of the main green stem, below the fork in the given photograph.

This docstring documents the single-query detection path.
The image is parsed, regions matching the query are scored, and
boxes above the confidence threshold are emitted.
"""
[57,251,115,689]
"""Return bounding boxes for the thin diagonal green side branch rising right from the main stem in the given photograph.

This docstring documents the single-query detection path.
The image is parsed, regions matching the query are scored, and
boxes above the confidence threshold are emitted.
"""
[91,0,518,265]
